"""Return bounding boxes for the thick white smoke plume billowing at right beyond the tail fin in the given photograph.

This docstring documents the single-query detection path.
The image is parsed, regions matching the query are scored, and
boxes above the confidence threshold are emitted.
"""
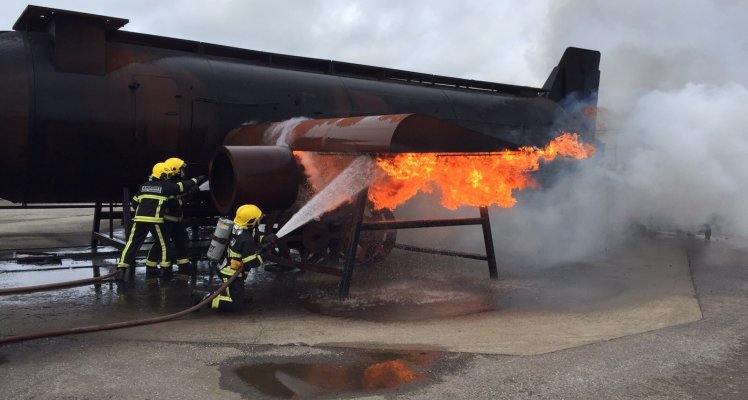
[400,0,748,265]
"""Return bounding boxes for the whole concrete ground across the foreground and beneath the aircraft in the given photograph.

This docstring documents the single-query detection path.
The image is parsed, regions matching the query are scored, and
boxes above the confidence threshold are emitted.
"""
[0,211,748,399]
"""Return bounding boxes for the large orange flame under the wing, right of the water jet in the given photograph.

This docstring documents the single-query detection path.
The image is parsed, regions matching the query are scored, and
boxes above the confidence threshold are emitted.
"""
[369,132,595,209]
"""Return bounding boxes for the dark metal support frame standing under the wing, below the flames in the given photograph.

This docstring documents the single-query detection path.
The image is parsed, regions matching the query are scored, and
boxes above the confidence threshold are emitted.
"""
[338,199,499,298]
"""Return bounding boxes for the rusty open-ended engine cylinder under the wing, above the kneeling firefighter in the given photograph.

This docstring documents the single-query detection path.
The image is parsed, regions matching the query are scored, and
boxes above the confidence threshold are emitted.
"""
[210,146,302,214]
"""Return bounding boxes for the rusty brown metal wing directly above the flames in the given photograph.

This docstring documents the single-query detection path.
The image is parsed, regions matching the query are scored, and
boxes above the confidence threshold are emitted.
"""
[225,114,518,153]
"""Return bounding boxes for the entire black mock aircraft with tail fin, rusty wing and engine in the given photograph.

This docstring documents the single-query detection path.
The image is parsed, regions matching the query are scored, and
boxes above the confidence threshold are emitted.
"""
[0,6,600,212]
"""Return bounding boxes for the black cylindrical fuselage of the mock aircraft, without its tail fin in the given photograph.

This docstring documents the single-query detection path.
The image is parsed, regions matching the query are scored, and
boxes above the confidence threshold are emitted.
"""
[0,7,599,203]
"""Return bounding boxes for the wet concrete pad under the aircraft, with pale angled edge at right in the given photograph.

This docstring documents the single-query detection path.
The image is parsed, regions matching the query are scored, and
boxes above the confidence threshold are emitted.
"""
[0,234,701,354]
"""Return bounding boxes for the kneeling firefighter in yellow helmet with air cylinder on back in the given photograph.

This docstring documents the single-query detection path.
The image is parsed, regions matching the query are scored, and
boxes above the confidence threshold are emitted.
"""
[212,204,263,311]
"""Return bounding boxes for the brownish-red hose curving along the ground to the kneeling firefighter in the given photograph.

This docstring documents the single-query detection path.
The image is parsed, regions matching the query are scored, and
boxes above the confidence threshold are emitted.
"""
[0,266,244,345]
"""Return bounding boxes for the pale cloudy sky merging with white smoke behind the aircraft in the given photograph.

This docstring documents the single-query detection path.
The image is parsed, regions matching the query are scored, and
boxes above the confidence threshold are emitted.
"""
[0,0,748,257]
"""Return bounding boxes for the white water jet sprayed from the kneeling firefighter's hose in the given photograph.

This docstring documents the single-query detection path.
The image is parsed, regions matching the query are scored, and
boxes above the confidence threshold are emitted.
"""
[278,156,374,237]
